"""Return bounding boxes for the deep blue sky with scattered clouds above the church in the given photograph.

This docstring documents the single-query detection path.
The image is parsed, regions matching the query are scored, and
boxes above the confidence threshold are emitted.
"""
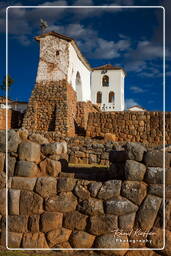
[0,0,171,111]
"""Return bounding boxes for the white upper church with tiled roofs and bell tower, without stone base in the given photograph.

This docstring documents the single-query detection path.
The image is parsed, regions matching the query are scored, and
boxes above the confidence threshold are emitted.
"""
[35,32,125,111]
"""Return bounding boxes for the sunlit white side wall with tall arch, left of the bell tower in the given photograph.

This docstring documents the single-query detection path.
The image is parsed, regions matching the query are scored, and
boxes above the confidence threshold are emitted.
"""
[67,43,91,101]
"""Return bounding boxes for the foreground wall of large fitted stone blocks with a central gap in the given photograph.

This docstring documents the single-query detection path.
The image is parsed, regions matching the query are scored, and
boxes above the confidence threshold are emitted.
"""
[0,130,171,256]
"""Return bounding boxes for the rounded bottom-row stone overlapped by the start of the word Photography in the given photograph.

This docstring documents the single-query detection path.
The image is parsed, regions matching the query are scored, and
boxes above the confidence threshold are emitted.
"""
[95,233,129,249]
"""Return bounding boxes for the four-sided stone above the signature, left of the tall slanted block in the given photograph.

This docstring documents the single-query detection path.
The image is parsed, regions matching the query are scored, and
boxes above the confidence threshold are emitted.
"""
[119,212,135,231]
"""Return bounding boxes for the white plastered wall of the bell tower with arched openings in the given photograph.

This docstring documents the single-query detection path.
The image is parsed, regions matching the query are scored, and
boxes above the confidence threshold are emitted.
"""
[91,70,125,111]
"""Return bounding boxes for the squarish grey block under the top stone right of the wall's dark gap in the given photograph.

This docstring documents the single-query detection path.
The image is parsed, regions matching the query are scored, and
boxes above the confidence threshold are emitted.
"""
[125,160,146,181]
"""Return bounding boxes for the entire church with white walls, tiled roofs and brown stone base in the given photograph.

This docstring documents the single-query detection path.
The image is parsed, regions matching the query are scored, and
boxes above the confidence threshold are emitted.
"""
[23,32,125,136]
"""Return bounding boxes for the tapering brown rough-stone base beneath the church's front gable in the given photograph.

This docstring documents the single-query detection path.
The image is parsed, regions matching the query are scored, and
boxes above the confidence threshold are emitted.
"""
[22,80,76,136]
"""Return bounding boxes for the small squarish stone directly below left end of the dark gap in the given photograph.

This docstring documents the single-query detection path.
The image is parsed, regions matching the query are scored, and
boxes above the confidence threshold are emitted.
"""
[57,178,76,192]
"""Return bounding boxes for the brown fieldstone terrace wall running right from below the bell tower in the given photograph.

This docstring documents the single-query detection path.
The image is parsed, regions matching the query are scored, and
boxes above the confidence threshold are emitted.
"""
[86,111,171,146]
